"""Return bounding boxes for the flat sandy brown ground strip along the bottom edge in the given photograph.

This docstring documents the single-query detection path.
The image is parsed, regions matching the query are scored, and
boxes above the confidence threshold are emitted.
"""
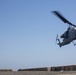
[0,71,76,75]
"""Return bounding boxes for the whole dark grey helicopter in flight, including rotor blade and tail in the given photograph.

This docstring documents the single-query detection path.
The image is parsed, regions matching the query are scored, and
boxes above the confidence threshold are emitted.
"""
[52,11,76,47]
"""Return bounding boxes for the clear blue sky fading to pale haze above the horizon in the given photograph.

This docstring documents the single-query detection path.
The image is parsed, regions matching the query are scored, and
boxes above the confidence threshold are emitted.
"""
[0,0,76,69]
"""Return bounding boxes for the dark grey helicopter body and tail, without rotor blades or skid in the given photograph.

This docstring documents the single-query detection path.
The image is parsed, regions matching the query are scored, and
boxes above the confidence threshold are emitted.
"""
[59,27,76,47]
